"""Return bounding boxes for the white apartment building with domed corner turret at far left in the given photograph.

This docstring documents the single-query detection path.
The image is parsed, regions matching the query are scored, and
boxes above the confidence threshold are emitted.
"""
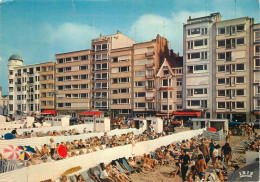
[8,55,41,116]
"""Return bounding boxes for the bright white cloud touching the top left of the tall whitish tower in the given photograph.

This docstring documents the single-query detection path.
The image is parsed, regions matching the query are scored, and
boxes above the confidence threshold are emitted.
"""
[129,11,205,54]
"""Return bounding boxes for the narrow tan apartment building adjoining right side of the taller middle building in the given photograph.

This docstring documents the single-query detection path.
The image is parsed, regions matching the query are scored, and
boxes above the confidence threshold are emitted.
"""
[109,47,133,117]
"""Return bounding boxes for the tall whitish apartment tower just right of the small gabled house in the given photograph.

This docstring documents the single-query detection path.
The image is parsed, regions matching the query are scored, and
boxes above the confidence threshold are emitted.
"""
[183,13,221,118]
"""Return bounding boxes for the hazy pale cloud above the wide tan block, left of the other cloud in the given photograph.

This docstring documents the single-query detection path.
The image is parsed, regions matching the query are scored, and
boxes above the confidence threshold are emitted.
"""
[45,22,101,53]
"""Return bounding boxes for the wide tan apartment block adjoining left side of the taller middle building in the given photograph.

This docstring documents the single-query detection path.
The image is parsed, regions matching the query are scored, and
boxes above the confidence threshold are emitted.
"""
[55,50,91,117]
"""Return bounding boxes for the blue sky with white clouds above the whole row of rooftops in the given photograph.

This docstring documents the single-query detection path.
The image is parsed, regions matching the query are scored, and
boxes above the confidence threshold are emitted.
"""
[0,0,260,94]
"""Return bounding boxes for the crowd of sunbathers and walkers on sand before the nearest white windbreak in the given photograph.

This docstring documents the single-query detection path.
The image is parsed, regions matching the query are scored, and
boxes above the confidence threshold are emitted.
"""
[58,133,259,182]
